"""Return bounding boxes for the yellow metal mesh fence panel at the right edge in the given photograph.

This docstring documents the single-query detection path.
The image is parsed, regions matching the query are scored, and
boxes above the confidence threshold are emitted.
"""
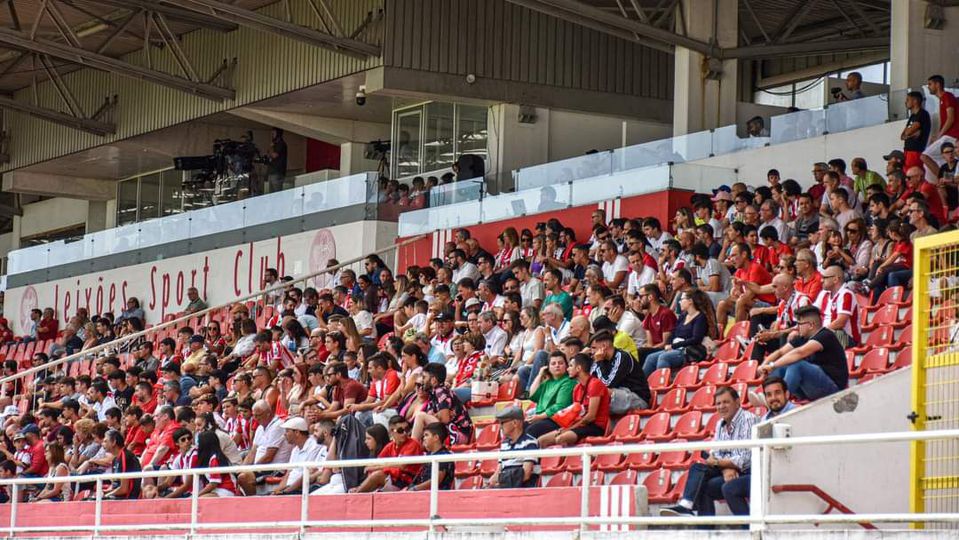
[909,231,959,524]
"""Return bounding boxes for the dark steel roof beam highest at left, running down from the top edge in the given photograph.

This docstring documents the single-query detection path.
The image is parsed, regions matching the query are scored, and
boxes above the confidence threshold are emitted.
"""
[158,0,380,60]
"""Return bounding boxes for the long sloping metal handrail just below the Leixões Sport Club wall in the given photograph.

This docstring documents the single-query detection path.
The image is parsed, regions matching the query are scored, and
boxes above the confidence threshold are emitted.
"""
[0,234,427,385]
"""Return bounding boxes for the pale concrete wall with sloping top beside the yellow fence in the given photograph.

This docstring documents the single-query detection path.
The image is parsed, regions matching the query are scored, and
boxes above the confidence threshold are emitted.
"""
[760,369,912,528]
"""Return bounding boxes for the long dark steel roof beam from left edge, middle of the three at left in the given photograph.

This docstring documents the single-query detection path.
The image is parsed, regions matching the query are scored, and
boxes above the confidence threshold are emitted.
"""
[0,28,236,101]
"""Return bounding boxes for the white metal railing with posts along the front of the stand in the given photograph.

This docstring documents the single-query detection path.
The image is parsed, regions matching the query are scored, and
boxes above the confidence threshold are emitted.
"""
[0,428,959,536]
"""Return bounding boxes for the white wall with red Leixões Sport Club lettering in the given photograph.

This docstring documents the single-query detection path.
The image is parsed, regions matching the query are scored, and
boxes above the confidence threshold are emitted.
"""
[3,221,386,334]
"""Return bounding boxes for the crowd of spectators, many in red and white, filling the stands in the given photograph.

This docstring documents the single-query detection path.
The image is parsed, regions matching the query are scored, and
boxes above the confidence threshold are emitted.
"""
[0,77,959,514]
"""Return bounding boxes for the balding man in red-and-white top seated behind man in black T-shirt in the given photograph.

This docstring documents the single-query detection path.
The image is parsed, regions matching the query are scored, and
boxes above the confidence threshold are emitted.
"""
[749,274,812,361]
